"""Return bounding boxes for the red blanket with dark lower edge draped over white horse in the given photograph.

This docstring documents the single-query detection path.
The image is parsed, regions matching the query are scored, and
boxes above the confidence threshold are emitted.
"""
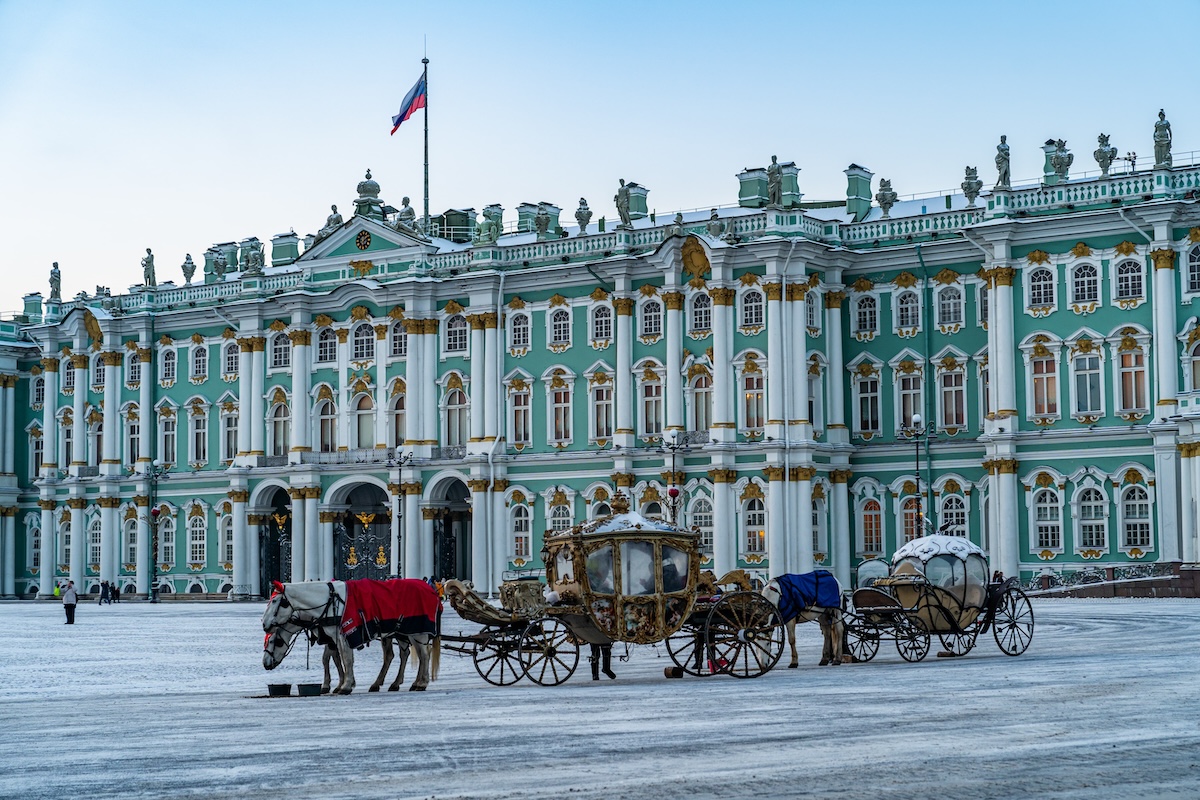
[342,578,442,648]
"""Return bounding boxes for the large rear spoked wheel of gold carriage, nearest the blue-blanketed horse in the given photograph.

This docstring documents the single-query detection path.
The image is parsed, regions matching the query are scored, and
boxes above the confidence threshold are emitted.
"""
[704,591,784,678]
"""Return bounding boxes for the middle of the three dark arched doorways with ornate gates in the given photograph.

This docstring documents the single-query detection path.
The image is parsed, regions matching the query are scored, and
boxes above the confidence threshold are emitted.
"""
[334,483,396,581]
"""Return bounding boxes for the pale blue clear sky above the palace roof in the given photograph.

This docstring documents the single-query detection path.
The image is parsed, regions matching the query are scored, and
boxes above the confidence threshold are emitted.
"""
[0,0,1200,314]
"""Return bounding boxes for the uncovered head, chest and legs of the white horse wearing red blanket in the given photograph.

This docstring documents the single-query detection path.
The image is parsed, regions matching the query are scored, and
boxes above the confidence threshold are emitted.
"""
[263,581,442,694]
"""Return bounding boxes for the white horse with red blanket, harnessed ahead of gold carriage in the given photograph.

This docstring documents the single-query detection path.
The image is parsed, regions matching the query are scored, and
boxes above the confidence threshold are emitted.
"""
[263,579,442,694]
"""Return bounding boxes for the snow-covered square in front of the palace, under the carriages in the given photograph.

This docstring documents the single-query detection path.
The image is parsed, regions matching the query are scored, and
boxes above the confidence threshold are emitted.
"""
[0,600,1200,800]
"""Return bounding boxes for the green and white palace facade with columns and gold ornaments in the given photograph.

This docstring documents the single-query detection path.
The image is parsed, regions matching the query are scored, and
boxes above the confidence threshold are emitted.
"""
[0,126,1200,597]
